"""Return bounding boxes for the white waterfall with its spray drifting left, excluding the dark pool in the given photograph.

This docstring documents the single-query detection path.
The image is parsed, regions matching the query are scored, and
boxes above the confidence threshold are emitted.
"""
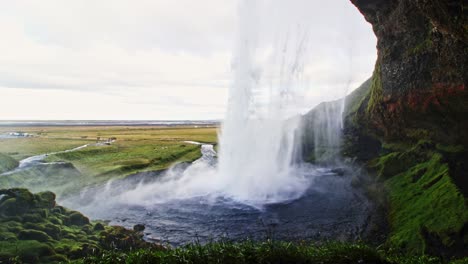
[67,0,372,212]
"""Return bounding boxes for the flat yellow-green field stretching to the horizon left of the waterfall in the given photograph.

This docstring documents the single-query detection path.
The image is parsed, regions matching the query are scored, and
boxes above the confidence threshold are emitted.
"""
[0,126,217,192]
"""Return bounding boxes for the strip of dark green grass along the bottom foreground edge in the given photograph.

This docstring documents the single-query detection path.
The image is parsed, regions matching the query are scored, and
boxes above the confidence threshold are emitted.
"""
[72,241,468,264]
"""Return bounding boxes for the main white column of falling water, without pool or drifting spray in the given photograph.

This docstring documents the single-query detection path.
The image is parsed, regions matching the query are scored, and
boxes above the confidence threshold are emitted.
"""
[218,1,308,202]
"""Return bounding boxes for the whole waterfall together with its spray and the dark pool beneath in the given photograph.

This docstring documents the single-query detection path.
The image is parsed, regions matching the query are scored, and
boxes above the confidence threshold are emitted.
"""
[54,0,376,243]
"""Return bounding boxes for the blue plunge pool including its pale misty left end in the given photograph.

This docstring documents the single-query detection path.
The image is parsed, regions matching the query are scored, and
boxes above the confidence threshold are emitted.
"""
[61,147,370,246]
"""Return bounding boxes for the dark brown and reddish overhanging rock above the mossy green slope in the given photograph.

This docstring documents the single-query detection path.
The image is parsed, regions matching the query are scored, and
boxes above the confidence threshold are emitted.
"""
[351,0,468,145]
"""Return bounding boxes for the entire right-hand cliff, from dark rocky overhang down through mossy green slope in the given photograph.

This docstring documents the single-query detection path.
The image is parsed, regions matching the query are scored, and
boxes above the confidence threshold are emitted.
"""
[343,0,468,257]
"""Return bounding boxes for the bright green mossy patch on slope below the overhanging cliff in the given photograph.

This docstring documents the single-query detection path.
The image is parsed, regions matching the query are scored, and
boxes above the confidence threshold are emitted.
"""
[386,153,468,254]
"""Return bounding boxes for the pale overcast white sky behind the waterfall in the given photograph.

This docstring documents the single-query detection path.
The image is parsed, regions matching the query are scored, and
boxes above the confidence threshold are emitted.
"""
[0,0,376,120]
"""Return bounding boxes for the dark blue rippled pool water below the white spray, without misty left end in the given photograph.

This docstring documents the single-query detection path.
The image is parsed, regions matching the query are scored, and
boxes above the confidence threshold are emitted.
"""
[100,175,368,245]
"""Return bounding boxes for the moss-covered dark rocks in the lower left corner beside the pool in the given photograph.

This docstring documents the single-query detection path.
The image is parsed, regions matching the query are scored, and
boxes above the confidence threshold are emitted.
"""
[0,188,163,263]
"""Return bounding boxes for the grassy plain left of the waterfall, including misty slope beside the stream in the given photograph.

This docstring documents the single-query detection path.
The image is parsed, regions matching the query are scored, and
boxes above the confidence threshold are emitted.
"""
[0,126,217,196]
